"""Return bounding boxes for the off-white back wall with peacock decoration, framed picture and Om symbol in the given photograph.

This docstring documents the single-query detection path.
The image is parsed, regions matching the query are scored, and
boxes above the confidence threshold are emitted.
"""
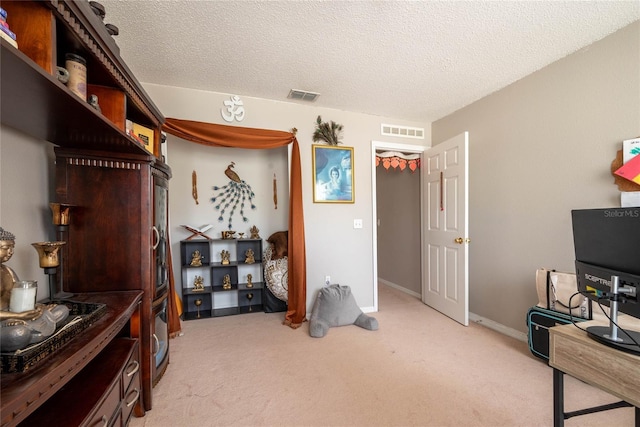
[145,84,431,310]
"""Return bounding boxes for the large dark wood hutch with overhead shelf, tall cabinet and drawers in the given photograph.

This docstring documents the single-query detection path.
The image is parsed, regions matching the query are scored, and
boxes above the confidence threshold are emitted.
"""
[0,0,171,426]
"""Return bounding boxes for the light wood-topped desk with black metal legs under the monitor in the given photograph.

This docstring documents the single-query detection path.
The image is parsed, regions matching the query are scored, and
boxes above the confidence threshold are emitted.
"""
[549,319,640,427]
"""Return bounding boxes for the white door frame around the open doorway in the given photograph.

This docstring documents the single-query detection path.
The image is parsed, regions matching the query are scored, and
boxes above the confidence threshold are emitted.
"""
[371,141,424,311]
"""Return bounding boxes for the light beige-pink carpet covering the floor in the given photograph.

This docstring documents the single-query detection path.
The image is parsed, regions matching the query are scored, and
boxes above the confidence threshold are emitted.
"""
[130,285,634,427]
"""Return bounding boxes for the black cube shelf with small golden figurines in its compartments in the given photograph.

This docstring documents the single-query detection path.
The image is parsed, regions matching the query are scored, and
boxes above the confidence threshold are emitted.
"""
[180,239,264,320]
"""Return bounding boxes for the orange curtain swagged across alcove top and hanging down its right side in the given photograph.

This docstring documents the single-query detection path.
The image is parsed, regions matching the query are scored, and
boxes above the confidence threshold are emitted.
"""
[162,118,307,329]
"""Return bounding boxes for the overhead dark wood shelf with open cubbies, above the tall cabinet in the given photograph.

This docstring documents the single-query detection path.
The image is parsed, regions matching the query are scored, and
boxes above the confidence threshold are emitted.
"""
[0,0,164,157]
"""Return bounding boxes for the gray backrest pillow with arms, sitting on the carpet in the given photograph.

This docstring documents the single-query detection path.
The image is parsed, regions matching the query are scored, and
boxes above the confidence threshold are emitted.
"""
[309,285,378,338]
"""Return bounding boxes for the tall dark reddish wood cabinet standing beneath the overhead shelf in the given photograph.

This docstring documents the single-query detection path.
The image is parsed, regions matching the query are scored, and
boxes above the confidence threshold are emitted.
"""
[55,148,170,410]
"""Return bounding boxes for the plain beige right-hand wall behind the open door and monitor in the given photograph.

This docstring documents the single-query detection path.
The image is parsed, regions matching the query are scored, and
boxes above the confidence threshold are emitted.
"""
[432,22,640,331]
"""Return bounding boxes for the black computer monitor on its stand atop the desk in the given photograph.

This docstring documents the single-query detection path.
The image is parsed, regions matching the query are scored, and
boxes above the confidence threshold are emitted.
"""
[571,207,640,354]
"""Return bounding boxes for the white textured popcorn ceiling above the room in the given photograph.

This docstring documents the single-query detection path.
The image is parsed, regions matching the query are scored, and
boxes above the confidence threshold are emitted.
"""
[98,0,640,122]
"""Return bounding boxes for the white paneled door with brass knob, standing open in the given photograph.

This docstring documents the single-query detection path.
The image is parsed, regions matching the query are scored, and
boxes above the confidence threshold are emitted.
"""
[422,132,469,326]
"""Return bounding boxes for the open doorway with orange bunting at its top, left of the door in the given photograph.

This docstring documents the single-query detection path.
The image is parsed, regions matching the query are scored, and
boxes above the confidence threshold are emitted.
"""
[371,141,426,311]
